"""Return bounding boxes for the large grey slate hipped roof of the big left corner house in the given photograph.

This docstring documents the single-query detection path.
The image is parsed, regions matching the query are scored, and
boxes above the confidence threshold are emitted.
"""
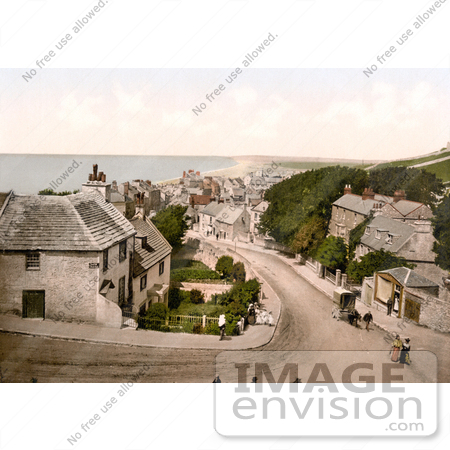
[0,192,136,251]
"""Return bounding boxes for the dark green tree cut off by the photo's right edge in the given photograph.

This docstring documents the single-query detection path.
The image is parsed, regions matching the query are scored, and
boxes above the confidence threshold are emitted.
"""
[431,196,450,270]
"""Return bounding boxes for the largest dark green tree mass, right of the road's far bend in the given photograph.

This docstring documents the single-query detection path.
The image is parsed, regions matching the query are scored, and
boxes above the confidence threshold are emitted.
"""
[260,166,368,248]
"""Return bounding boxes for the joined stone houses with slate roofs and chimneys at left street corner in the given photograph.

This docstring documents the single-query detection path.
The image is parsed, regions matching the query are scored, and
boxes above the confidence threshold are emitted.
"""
[0,168,172,328]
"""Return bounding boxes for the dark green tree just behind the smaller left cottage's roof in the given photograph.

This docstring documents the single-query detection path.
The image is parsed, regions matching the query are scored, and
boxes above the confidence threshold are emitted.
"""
[152,205,188,251]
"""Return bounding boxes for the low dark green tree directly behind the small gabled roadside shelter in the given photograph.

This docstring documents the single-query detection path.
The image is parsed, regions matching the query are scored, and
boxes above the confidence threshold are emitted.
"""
[347,249,416,283]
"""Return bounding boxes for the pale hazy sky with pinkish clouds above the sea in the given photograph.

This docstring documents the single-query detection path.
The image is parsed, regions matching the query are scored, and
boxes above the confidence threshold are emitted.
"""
[0,68,450,159]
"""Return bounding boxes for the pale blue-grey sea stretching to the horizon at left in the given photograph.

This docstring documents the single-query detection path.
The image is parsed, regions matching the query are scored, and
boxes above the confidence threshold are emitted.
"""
[0,154,238,194]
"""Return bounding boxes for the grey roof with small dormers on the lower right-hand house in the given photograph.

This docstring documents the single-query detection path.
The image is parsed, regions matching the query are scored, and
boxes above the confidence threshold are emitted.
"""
[361,216,416,253]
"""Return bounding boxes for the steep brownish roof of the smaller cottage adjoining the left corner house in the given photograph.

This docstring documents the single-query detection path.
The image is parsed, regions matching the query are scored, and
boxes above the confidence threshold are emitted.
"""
[130,217,172,277]
